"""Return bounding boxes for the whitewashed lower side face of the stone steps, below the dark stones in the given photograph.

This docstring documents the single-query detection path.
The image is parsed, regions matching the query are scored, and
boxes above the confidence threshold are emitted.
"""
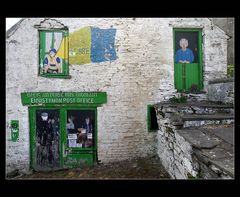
[157,127,199,179]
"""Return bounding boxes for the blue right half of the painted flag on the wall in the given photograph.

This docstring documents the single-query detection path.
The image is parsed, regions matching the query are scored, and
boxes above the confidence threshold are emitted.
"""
[91,27,117,62]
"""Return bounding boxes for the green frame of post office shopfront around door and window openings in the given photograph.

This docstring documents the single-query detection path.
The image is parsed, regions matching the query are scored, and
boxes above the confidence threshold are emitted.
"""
[28,105,98,169]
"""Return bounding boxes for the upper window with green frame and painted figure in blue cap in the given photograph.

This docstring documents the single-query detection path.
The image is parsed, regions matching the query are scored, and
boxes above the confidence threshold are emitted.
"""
[39,30,69,78]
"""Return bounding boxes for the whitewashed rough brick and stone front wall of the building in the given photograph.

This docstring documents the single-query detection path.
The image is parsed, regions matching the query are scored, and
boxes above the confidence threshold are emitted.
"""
[6,18,226,172]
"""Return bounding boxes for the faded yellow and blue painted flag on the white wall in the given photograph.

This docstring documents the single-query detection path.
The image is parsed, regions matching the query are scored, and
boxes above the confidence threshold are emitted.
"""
[69,27,117,65]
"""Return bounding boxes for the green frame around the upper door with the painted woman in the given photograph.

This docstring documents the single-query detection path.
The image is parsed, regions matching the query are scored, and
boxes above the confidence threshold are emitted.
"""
[173,27,204,90]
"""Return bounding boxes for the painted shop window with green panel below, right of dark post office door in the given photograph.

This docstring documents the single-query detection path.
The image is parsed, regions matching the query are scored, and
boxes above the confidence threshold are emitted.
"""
[62,108,97,168]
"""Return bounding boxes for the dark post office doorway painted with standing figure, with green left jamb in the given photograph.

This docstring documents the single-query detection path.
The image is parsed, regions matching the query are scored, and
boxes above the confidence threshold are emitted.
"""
[29,108,61,171]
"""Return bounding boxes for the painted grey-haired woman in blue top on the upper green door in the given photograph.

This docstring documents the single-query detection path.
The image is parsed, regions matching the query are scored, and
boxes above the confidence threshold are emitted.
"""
[176,38,194,63]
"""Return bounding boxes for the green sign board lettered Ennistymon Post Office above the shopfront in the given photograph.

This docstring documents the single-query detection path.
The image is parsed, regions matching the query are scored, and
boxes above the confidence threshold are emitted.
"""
[21,92,107,105]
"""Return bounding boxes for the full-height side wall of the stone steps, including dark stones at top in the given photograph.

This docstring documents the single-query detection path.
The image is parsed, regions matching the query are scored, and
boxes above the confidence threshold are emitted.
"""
[156,103,199,179]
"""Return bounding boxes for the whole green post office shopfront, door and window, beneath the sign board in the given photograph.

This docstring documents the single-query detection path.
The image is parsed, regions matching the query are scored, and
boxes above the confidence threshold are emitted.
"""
[29,106,97,171]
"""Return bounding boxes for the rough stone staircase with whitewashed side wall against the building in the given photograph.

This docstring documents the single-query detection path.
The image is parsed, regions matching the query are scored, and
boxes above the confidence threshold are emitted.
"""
[155,102,233,179]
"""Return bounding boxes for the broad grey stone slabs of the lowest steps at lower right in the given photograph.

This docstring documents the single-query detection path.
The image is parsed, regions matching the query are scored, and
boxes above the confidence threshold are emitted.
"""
[178,125,234,178]
